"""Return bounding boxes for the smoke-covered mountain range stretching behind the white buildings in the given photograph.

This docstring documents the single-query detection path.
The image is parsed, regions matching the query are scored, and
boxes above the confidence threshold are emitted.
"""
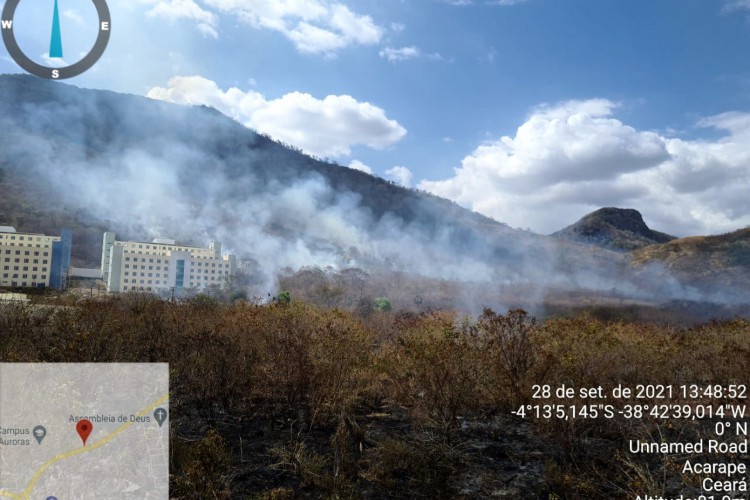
[0,75,748,299]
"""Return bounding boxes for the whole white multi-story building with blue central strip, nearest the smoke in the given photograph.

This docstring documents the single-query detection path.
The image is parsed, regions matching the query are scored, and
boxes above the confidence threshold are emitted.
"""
[102,232,237,292]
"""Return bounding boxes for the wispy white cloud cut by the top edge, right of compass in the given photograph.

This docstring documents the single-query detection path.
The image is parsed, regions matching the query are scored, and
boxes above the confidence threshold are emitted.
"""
[204,0,384,55]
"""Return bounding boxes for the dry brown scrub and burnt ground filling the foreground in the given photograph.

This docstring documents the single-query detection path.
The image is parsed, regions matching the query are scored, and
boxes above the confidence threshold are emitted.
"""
[0,294,750,499]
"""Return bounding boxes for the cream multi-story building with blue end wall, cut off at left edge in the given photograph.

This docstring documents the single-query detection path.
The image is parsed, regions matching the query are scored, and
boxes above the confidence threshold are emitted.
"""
[0,226,73,288]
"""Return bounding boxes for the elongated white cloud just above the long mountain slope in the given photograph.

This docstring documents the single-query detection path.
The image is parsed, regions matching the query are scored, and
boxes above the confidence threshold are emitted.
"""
[148,76,406,157]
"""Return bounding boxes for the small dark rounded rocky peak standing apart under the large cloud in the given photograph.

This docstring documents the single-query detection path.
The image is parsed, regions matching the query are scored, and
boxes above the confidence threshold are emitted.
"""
[551,207,675,252]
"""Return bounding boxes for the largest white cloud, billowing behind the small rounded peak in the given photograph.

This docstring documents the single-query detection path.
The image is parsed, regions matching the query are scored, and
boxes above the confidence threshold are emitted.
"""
[418,99,750,235]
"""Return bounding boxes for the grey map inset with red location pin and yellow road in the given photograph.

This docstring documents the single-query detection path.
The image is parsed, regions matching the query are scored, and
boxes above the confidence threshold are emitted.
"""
[0,363,169,500]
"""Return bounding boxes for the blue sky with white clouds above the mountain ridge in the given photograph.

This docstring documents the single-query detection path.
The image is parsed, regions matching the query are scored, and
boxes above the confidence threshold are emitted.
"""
[0,0,750,236]
